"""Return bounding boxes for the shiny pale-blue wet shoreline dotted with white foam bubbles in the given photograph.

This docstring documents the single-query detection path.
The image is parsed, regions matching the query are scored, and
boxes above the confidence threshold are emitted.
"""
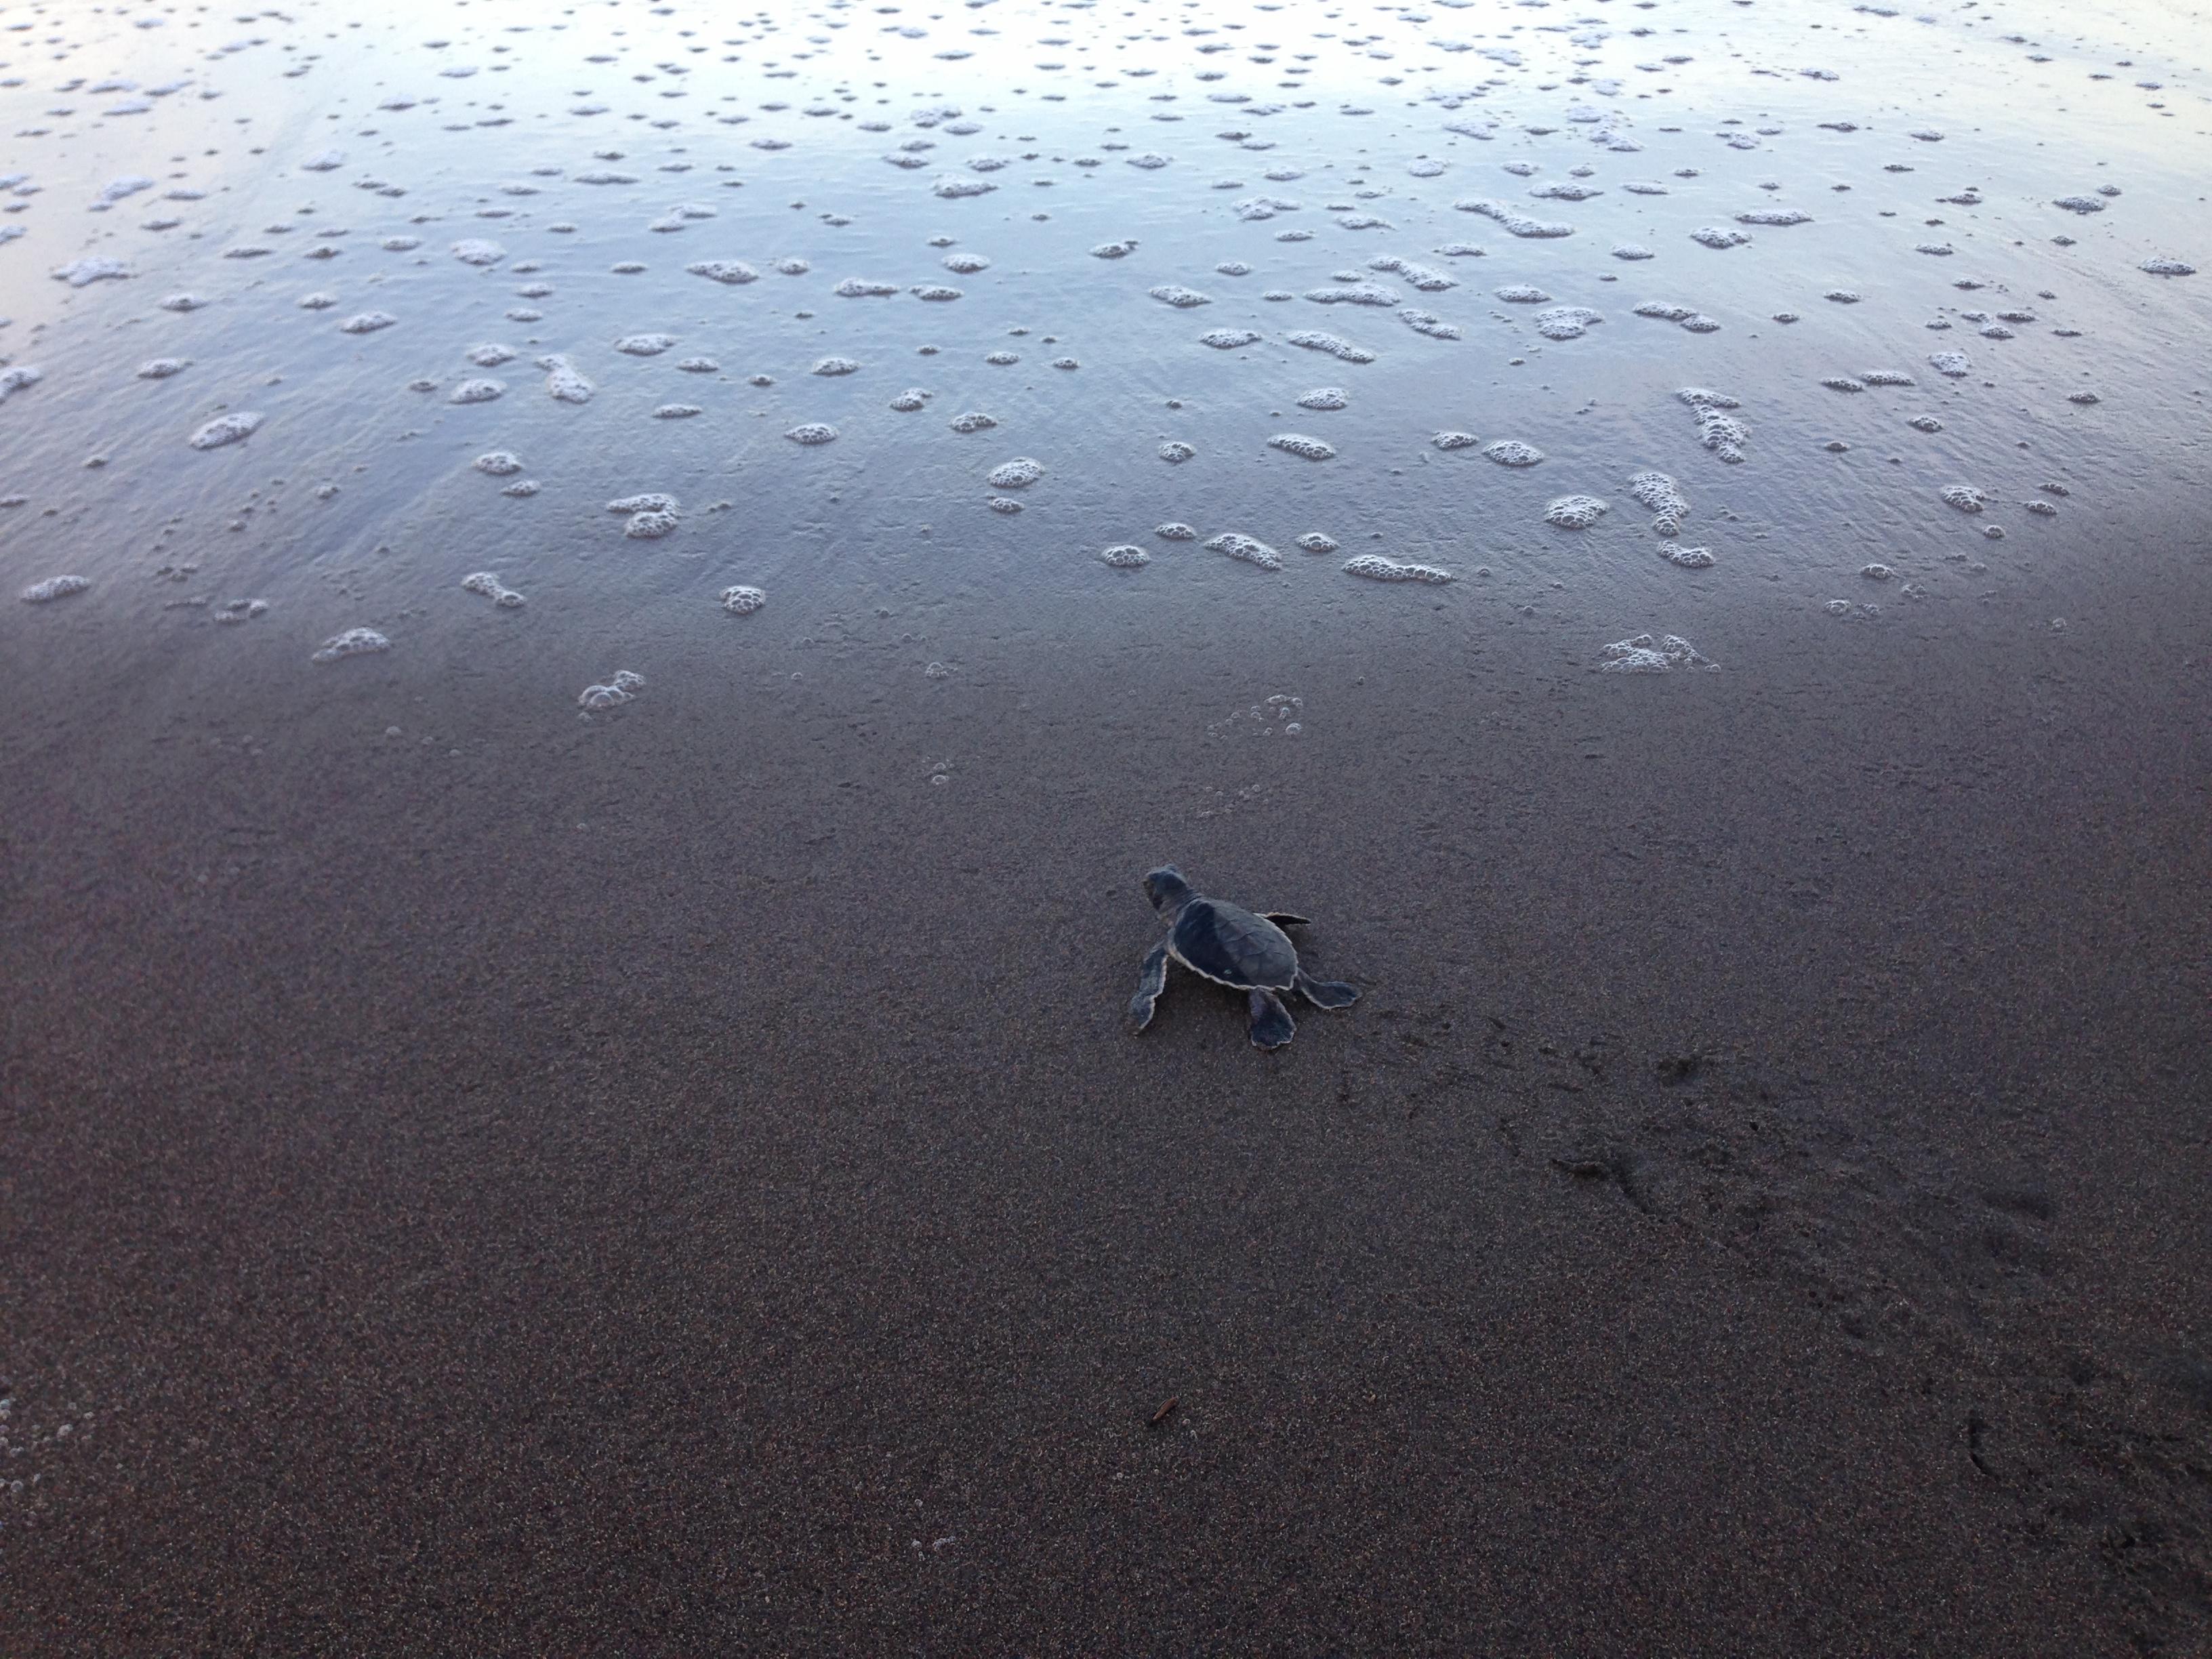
[0,0,2205,694]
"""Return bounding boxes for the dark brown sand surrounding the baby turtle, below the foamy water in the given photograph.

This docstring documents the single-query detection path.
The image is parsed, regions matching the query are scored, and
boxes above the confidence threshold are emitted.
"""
[0,513,2212,1657]
